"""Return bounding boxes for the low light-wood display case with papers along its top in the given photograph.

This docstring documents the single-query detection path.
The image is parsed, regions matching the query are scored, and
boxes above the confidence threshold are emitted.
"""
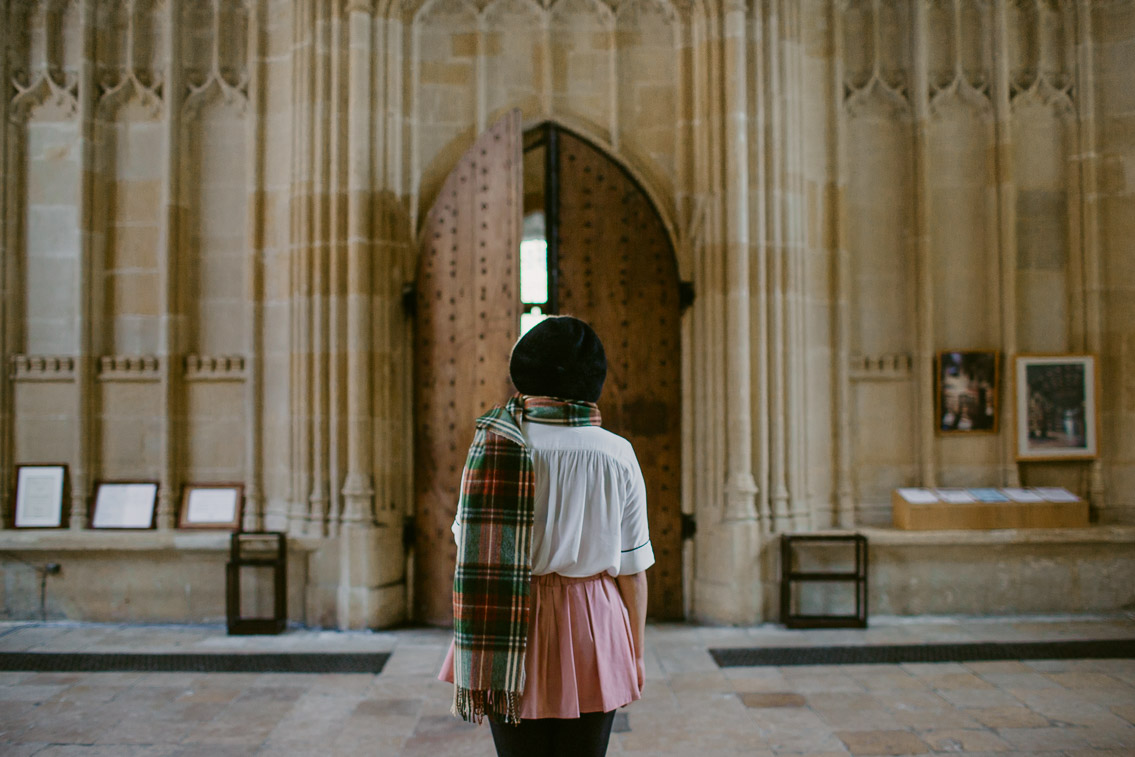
[891,489,1088,531]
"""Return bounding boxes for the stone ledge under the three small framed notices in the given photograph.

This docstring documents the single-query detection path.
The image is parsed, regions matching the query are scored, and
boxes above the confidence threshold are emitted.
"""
[0,529,326,554]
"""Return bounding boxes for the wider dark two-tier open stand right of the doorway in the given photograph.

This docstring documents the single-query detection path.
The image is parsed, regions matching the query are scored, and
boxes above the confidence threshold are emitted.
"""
[781,533,867,629]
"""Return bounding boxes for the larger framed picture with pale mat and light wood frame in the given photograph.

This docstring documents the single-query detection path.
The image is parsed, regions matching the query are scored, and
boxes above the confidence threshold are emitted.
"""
[1014,355,1100,460]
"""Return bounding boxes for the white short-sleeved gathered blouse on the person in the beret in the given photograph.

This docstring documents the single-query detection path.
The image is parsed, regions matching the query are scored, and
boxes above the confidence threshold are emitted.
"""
[453,421,654,577]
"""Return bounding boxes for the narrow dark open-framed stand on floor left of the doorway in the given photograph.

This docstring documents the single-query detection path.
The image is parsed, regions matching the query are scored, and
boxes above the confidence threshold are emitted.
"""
[225,531,287,636]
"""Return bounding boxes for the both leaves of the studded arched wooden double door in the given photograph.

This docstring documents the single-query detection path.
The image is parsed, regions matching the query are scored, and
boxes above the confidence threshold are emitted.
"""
[414,118,683,625]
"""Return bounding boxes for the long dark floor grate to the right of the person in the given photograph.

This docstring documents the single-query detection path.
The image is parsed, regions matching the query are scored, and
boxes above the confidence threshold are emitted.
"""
[709,639,1135,667]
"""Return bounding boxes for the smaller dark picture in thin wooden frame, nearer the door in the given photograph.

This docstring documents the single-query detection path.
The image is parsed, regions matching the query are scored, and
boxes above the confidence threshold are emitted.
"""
[934,351,1000,435]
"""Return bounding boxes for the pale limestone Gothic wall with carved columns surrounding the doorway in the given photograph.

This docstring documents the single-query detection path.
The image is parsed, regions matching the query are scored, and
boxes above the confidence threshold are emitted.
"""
[0,0,1135,628]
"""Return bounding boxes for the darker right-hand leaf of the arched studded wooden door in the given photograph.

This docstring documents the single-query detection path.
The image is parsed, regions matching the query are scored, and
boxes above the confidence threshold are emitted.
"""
[549,131,683,620]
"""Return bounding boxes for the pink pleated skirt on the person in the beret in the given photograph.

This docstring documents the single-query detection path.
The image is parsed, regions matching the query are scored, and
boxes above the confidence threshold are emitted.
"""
[438,573,641,720]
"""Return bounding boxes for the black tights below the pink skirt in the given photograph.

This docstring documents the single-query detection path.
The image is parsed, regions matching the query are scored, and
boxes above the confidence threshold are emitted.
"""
[489,710,615,757]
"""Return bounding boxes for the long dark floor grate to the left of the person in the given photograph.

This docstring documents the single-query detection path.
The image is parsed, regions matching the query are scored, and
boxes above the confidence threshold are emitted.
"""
[0,651,390,675]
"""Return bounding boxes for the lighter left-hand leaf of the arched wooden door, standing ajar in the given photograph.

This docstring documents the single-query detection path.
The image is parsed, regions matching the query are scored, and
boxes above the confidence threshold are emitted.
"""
[413,110,522,625]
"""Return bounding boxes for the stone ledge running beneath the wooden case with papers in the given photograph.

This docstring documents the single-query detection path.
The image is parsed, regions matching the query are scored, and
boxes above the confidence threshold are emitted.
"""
[856,525,1135,547]
